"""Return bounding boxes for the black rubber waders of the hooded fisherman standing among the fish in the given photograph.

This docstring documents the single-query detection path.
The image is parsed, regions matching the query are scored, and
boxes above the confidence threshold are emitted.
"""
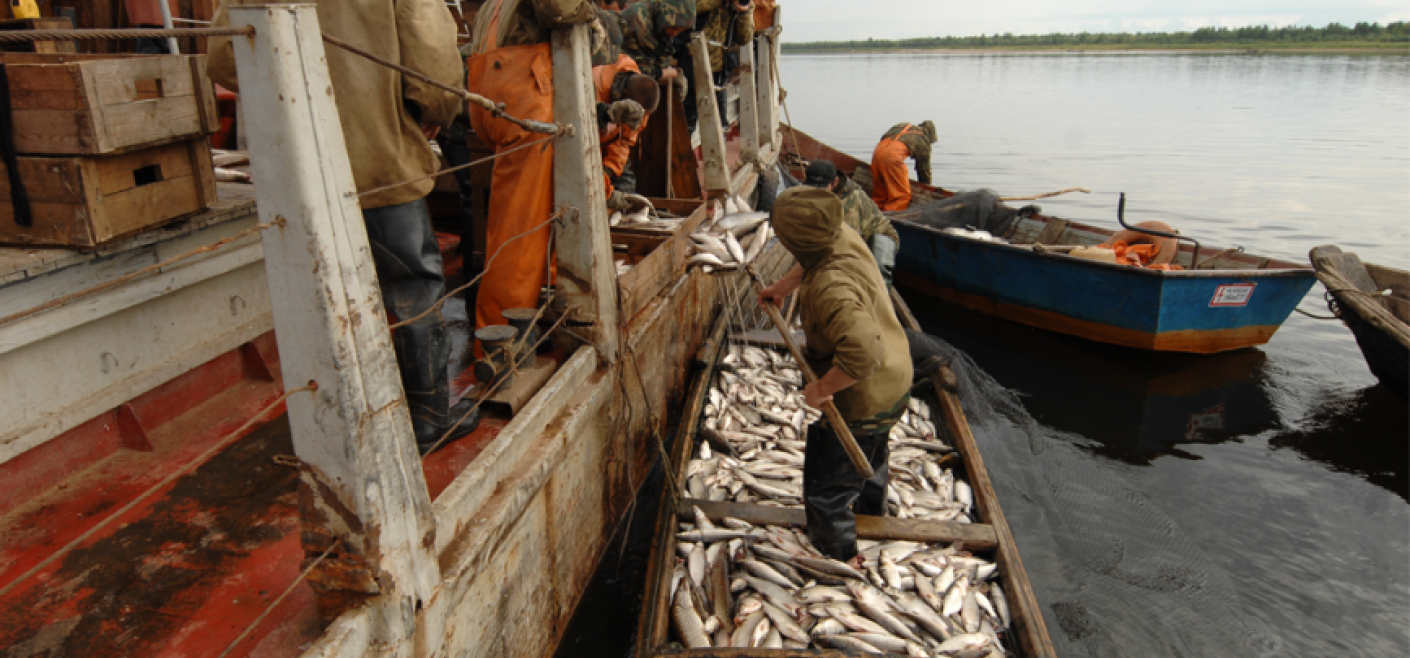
[802,418,890,562]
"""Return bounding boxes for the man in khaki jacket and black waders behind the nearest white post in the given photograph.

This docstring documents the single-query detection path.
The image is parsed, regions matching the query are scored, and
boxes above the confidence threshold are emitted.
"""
[207,0,479,454]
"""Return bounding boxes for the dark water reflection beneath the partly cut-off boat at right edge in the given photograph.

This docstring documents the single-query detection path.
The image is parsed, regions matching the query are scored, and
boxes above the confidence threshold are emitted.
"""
[1269,383,1410,500]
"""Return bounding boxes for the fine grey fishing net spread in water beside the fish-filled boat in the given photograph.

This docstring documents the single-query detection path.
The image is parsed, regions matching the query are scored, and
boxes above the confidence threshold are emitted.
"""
[909,333,1280,658]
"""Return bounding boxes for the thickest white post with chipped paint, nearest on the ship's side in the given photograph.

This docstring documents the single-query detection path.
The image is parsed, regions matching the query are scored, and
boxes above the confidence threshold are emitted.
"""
[230,4,440,644]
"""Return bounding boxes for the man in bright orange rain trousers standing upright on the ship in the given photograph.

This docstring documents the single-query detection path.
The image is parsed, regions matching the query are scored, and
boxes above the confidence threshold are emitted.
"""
[465,0,596,356]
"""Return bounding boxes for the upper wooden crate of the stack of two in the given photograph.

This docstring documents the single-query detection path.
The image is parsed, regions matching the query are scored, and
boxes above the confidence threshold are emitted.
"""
[0,54,220,155]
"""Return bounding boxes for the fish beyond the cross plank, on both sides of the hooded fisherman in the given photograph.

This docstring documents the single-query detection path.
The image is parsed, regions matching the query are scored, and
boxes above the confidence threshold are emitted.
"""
[685,344,974,523]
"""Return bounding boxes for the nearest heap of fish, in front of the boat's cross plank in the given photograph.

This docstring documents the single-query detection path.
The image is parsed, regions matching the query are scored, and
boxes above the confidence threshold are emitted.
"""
[668,507,1011,658]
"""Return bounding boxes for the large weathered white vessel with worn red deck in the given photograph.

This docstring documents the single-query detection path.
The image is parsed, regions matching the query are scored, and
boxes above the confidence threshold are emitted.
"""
[0,11,783,658]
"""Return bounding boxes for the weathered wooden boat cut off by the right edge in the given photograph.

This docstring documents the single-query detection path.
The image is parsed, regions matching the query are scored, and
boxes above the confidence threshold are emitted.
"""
[1308,245,1410,397]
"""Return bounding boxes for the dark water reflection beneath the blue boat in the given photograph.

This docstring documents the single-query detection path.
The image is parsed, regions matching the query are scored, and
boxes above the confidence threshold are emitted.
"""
[912,296,1280,465]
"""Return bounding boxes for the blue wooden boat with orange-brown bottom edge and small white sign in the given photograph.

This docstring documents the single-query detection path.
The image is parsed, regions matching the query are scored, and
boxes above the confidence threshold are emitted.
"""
[785,128,1314,354]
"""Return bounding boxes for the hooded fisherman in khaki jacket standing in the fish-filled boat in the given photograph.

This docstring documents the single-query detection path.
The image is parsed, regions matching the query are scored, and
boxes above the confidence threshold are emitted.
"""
[759,186,911,561]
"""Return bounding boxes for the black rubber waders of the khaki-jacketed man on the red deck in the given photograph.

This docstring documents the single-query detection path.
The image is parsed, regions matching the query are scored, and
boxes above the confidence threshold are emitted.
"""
[362,200,479,455]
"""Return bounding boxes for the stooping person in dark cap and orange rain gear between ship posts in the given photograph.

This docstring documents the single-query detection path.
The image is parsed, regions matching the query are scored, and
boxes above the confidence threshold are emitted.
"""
[592,55,661,210]
